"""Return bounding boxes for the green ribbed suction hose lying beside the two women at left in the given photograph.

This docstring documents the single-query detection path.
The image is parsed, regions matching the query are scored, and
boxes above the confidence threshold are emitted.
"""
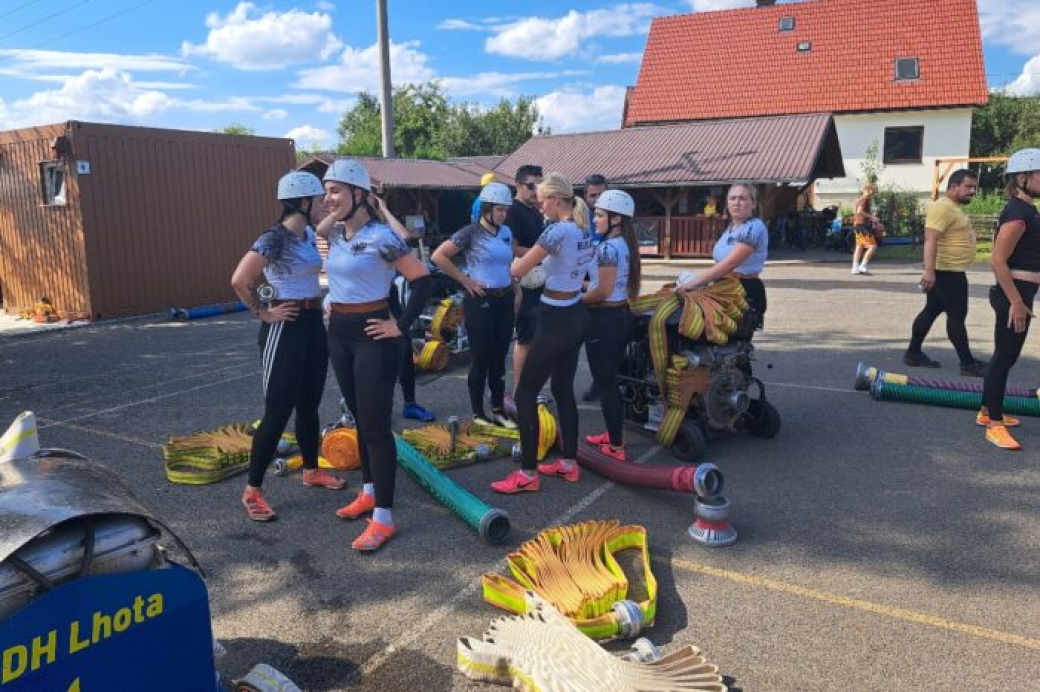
[394,436,511,545]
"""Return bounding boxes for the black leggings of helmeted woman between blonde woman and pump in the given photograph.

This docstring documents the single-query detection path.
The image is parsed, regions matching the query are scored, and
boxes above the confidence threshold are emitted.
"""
[586,305,631,446]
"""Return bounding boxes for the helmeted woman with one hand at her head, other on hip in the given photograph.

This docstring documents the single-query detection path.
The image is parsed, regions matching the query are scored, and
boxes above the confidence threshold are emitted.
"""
[318,159,433,550]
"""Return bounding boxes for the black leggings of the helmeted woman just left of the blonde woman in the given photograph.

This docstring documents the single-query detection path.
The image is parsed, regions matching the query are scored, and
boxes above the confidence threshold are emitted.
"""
[462,290,516,415]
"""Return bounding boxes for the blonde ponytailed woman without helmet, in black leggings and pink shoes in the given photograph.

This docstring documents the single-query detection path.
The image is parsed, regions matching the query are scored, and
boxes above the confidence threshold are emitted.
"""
[491,173,595,493]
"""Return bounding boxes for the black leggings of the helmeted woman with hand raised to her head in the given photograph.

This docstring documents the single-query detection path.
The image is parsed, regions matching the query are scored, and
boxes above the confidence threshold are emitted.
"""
[329,309,404,509]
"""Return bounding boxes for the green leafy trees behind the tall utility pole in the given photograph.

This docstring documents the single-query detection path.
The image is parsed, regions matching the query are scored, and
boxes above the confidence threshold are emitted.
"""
[337,82,543,159]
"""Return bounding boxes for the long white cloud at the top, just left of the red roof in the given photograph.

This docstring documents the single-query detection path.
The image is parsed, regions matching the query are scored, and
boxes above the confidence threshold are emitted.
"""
[485,3,660,60]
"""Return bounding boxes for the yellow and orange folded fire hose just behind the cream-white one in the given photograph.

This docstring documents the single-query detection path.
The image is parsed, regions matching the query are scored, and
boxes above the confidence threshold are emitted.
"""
[483,519,657,640]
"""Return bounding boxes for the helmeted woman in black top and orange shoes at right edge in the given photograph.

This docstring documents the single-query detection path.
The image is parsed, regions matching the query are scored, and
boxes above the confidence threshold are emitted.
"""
[976,149,1040,450]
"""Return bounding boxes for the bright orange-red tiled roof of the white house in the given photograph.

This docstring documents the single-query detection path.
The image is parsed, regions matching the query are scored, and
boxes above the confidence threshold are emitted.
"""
[625,0,987,126]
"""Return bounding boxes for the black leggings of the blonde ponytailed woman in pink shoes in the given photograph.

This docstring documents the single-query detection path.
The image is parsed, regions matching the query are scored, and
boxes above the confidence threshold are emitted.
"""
[516,302,586,471]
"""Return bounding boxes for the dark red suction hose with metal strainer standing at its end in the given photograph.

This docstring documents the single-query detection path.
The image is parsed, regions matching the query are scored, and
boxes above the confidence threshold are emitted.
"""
[578,442,736,547]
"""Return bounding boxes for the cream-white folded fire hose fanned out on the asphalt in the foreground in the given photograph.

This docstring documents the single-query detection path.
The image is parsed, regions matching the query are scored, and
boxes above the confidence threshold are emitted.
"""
[456,591,728,692]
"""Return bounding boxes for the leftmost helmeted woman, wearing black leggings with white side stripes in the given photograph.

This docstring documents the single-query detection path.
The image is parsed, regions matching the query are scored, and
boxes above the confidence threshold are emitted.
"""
[231,171,345,521]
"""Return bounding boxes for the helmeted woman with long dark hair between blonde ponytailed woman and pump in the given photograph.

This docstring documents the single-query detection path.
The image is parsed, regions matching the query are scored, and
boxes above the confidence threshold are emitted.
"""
[581,189,641,461]
